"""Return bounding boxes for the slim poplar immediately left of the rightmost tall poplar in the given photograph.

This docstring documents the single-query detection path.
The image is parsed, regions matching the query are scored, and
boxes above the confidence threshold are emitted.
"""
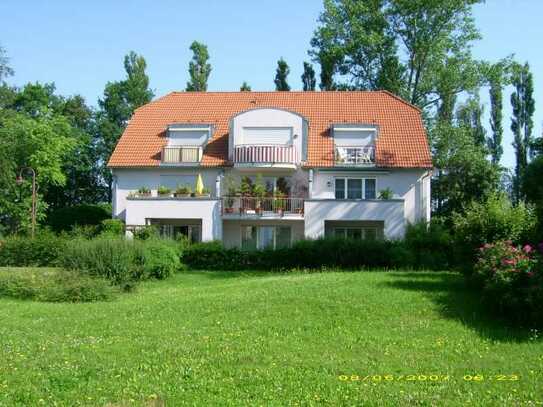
[487,63,504,165]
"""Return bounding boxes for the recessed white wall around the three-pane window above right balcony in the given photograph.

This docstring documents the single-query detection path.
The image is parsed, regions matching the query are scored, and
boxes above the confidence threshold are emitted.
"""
[311,169,430,223]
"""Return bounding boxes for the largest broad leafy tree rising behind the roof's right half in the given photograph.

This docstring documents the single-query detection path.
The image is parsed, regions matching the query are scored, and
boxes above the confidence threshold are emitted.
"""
[310,0,481,108]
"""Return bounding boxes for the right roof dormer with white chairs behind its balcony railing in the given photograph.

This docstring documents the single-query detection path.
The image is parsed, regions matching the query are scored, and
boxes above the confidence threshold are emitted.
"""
[332,124,377,165]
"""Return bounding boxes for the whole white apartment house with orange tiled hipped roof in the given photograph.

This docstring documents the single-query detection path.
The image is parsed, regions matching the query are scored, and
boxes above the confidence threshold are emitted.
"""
[108,91,432,249]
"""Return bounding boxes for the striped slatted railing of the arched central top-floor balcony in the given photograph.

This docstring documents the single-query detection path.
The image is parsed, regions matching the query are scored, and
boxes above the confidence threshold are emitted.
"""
[234,145,298,164]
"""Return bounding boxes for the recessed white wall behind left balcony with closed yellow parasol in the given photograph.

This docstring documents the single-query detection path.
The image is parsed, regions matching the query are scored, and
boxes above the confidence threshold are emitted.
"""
[112,167,220,224]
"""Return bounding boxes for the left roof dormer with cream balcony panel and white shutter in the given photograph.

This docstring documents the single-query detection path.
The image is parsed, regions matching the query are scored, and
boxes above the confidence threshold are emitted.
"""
[162,123,213,165]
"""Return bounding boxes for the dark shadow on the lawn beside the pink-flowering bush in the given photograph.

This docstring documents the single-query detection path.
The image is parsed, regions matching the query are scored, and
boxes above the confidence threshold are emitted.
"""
[381,272,533,342]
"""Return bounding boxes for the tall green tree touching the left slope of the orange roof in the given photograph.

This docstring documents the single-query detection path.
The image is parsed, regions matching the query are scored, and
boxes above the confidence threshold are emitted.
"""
[96,52,154,199]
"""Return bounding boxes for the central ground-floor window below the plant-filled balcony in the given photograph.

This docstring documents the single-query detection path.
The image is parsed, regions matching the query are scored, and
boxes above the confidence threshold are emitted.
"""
[241,225,292,250]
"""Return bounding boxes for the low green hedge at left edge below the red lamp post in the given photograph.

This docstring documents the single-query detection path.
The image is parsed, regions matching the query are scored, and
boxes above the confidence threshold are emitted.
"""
[0,231,66,267]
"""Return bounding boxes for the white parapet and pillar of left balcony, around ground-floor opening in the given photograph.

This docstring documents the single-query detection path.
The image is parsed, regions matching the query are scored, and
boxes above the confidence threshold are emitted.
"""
[126,198,222,241]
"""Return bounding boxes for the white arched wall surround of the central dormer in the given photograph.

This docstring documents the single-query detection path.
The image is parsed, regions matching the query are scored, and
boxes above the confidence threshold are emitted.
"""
[228,108,304,163]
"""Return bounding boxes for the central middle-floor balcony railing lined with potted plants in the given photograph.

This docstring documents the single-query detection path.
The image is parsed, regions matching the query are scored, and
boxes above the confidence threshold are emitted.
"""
[222,196,304,216]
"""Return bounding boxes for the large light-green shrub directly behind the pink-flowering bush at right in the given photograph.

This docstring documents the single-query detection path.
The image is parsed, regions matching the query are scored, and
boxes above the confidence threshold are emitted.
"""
[453,194,537,274]
